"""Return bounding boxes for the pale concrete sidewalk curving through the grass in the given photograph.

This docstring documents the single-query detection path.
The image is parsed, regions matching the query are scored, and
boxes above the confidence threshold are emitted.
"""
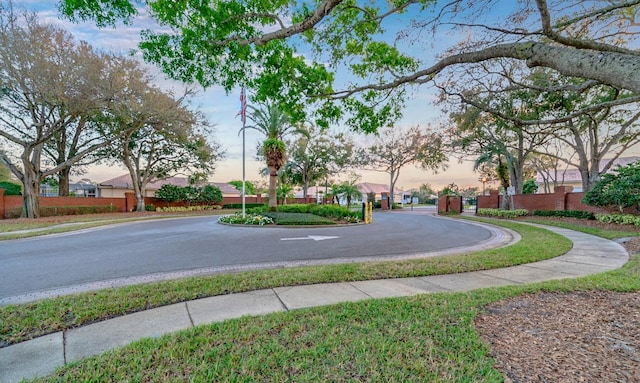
[0,225,629,382]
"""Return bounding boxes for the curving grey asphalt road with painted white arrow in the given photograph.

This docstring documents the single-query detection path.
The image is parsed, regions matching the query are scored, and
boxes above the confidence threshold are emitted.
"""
[0,211,491,304]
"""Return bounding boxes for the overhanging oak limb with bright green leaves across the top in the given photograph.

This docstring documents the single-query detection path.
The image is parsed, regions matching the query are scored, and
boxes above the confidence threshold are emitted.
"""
[60,0,640,132]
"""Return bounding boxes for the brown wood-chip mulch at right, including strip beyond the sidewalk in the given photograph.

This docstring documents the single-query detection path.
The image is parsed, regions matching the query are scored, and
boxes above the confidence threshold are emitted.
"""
[476,218,640,383]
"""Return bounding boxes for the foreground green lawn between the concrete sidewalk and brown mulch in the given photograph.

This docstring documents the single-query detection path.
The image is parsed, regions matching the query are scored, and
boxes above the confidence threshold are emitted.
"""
[30,256,640,382]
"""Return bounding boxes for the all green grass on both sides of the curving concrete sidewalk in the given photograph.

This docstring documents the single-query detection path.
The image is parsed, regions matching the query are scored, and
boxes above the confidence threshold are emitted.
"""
[0,214,640,382]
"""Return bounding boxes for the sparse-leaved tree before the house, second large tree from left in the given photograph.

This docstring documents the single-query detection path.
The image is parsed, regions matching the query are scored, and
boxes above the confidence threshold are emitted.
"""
[103,64,224,211]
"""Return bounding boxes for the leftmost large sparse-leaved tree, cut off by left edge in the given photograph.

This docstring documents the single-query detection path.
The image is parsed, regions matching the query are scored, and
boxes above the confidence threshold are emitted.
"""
[0,7,112,218]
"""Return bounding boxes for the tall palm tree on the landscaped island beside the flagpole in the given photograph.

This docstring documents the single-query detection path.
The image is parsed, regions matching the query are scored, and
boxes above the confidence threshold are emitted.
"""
[243,103,309,210]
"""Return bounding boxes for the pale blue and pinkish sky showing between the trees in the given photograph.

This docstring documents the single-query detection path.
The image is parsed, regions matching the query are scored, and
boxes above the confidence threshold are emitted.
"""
[26,0,482,190]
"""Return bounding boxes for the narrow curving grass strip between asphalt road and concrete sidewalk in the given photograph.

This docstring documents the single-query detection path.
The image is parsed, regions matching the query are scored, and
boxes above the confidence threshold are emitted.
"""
[0,221,571,344]
